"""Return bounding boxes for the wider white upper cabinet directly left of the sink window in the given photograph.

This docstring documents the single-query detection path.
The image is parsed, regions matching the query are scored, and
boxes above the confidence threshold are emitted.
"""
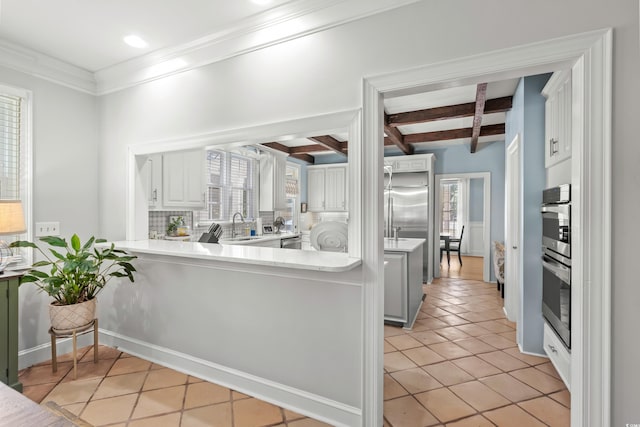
[162,150,205,209]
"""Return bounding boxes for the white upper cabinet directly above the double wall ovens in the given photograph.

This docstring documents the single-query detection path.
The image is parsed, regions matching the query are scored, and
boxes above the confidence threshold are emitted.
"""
[542,70,572,168]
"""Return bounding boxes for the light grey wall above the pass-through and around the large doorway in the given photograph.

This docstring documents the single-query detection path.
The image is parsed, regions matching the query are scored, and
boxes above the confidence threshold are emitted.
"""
[100,0,640,425]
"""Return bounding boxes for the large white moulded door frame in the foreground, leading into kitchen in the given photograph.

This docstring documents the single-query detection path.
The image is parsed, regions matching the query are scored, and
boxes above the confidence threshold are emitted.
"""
[359,28,613,427]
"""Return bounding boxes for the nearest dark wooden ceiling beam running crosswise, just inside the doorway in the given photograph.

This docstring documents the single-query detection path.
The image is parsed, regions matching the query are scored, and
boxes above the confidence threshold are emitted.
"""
[385,96,513,127]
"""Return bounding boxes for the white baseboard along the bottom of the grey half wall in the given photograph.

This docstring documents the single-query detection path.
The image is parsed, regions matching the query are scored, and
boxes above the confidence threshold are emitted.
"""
[99,329,362,427]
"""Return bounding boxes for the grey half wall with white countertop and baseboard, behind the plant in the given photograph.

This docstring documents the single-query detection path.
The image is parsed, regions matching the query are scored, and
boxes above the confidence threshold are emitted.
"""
[99,240,364,426]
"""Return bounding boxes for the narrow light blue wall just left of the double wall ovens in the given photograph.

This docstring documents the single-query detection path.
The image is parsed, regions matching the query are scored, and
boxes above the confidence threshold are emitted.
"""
[505,74,550,354]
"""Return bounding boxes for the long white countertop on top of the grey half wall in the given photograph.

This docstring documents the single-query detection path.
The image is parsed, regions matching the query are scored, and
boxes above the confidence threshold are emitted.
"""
[113,239,362,272]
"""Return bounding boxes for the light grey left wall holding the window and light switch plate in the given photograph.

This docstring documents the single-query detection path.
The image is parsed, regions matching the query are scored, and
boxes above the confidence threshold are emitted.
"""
[0,63,99,356]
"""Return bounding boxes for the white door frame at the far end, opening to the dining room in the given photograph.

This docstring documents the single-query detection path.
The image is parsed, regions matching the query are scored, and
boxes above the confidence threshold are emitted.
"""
[432,172,491,282]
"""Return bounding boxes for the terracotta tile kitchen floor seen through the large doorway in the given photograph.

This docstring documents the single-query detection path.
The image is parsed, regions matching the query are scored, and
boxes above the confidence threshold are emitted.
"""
[384,278,570,427]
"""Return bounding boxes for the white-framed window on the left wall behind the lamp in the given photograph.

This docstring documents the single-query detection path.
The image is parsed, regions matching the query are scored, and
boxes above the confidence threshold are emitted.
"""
[0,85,31,268]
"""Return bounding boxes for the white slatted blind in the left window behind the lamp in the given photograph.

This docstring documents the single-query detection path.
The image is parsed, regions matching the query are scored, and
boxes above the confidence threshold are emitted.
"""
[0,94,22,200]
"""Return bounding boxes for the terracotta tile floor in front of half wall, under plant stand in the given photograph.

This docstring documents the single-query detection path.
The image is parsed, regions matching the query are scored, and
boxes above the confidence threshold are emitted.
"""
[19,346,327,427]
